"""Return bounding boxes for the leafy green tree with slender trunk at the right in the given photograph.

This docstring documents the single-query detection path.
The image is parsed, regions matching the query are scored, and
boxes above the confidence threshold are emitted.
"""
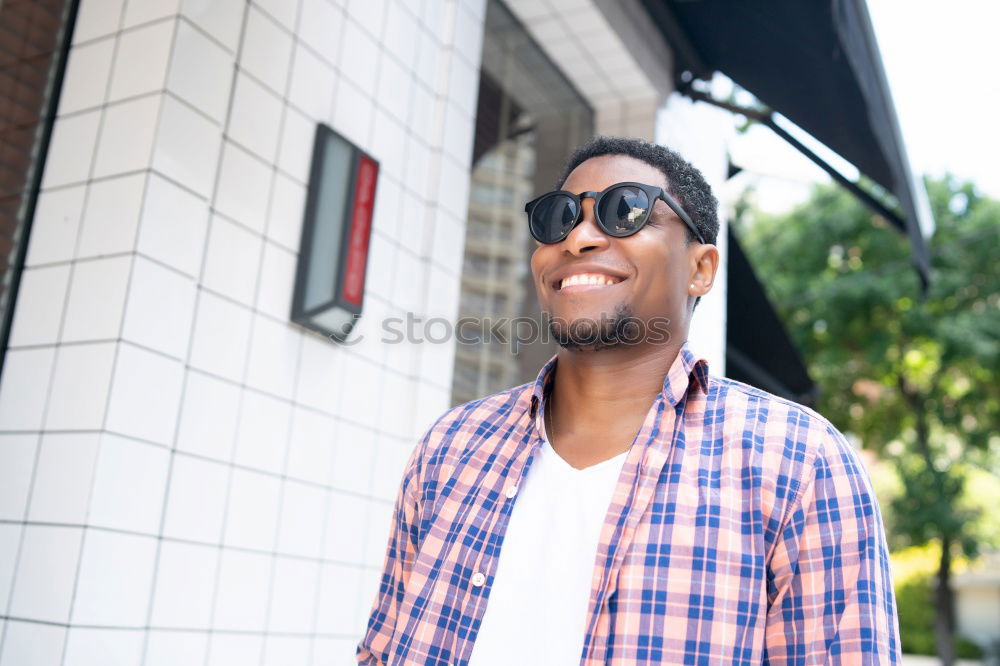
[734,177,1000,665]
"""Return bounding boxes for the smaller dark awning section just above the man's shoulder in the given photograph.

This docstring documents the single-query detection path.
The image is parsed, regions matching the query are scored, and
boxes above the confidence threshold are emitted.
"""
[726,228,818,406]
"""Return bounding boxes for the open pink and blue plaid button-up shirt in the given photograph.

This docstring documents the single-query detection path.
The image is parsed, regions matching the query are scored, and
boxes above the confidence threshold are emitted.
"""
[357,344,900,666]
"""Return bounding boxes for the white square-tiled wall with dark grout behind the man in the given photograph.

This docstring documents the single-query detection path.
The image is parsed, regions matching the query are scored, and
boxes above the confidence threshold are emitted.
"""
[0,0,485,666]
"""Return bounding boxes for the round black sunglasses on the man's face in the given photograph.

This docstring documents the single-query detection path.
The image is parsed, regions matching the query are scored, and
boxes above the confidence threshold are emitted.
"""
[524,183,705,245]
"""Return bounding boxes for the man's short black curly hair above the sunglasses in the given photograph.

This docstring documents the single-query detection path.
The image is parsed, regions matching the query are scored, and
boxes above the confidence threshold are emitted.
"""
[556,136,719,245]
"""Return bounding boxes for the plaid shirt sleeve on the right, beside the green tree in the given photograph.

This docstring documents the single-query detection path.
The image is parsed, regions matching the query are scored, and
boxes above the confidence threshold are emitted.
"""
[765,426,901,664]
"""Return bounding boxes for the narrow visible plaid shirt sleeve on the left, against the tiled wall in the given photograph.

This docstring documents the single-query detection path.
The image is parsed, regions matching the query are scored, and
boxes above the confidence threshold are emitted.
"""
[355,442,423,666]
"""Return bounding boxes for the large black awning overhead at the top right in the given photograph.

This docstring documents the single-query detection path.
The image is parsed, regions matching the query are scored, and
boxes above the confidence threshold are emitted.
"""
[643,0,933,290]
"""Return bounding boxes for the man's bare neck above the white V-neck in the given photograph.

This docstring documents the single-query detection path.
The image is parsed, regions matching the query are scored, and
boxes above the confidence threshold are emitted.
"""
[546,341,683,468]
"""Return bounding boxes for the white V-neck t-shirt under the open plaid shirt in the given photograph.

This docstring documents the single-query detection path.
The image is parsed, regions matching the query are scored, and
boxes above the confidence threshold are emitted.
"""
[469,439,628,666]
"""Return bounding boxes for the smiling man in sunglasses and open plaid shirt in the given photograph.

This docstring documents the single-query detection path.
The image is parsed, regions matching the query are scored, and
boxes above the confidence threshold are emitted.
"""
[357,137,899,666]
